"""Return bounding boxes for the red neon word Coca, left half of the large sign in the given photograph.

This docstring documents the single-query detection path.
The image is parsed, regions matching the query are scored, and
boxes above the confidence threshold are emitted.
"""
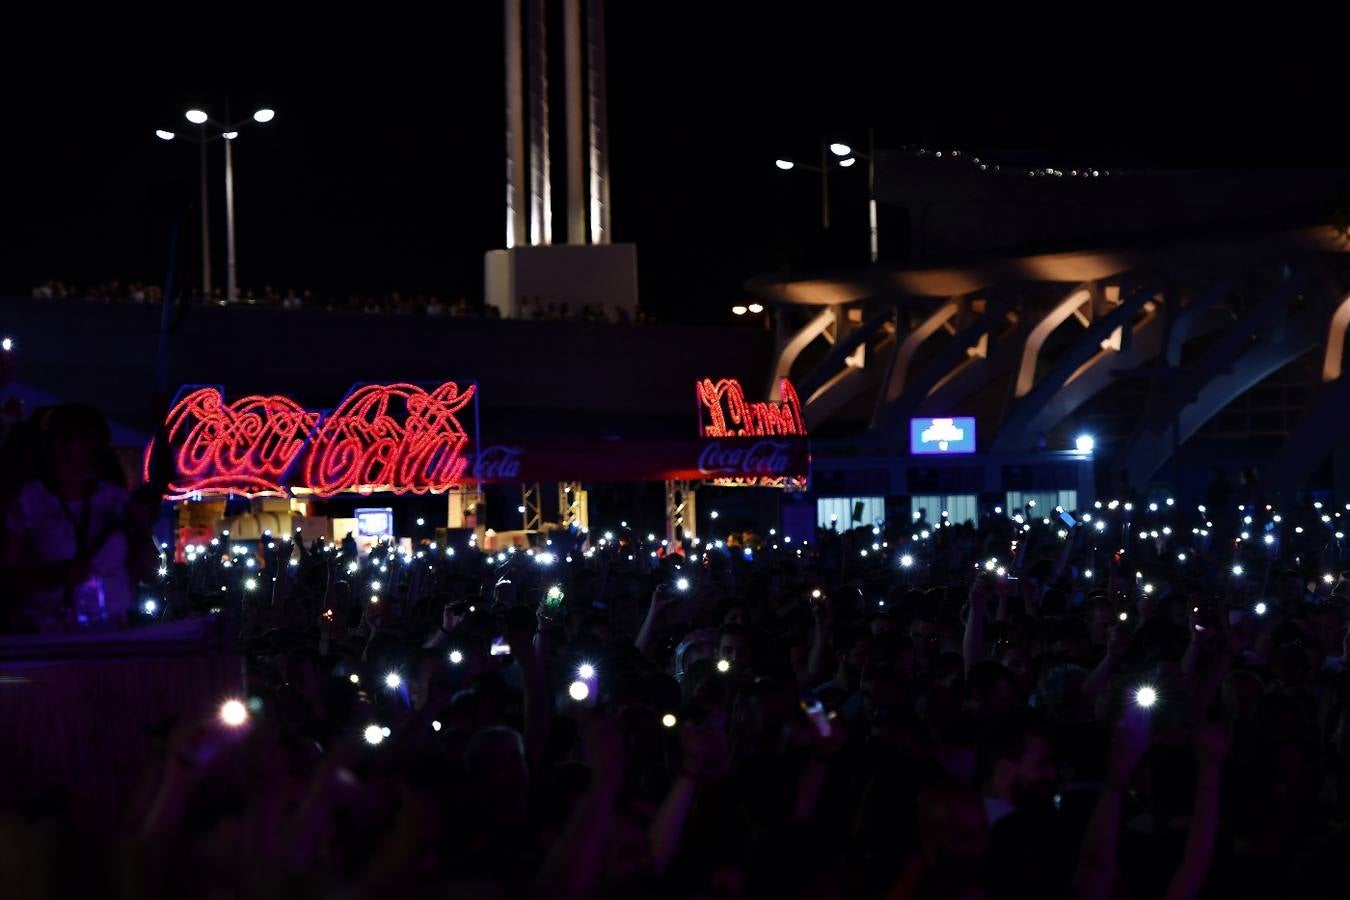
[144,387,319,499]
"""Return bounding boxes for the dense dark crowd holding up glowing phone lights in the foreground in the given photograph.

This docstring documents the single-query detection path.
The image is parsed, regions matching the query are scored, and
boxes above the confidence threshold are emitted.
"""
[0,410,1350,900]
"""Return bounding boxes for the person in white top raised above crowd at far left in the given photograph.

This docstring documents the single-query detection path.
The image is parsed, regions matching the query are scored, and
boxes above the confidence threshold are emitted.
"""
[0,403,158,633]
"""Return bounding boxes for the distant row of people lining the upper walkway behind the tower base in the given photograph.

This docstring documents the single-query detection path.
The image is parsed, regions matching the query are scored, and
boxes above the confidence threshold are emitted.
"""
[24,279,647,324]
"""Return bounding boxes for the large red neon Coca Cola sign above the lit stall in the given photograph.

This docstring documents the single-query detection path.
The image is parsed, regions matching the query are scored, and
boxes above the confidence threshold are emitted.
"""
[144,382,477,499]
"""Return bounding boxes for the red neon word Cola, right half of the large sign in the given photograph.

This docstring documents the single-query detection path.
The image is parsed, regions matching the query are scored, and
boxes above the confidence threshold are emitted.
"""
[305,382,474,497]
